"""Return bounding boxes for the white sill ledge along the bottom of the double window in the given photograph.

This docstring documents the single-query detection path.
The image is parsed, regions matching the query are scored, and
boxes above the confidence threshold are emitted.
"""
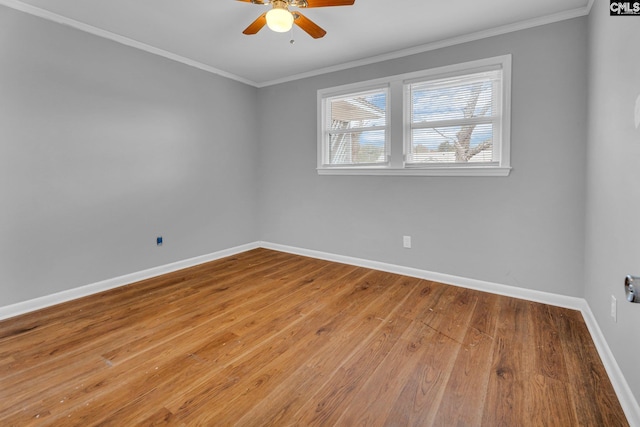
[317,166,511,176]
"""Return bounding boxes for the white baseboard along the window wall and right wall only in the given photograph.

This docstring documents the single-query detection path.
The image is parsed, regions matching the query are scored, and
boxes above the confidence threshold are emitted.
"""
[260,242,640,427]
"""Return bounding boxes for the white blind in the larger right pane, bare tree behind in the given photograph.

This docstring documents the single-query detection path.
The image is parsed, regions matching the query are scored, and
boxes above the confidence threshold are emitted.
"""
[405,69,502,166]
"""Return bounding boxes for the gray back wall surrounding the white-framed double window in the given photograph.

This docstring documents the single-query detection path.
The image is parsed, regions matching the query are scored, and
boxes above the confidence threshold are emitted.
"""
[259,18,588,297]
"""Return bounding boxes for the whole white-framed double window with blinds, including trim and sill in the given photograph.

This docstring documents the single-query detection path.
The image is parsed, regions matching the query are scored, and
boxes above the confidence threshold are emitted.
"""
[318,55,511,176]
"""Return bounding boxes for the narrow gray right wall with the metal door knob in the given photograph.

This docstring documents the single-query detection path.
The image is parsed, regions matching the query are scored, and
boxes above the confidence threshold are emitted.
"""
[585,0,640,401]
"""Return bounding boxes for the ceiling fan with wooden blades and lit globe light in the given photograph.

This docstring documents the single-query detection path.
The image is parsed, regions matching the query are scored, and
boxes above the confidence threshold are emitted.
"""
[237,0,355,39]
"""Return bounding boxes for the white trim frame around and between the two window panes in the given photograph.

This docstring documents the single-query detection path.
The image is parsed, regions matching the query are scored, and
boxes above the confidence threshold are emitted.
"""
[317,54,511,176]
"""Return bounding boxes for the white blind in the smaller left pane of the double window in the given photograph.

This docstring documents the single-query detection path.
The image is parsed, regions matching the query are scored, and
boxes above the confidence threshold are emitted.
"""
[323,88,389,166]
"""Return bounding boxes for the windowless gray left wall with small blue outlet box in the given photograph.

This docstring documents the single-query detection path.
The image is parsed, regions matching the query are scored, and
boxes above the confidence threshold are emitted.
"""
[0,6,259,306]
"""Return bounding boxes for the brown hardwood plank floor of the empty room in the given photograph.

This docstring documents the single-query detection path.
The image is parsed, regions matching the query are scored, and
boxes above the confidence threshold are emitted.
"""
[0,249,628,426]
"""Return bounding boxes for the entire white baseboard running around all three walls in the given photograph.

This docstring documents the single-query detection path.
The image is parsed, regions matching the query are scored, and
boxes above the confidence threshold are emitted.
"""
[0,242,640,427]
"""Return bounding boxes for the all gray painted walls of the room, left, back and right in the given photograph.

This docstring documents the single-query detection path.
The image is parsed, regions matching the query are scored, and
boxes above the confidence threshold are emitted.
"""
[0,0,640,408]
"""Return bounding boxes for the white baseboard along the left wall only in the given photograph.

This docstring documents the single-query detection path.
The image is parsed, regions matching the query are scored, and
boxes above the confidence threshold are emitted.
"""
[0,242,260,320]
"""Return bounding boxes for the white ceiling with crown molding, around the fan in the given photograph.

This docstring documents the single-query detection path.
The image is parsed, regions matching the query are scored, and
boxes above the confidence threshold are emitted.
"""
[0,0,593,87]
